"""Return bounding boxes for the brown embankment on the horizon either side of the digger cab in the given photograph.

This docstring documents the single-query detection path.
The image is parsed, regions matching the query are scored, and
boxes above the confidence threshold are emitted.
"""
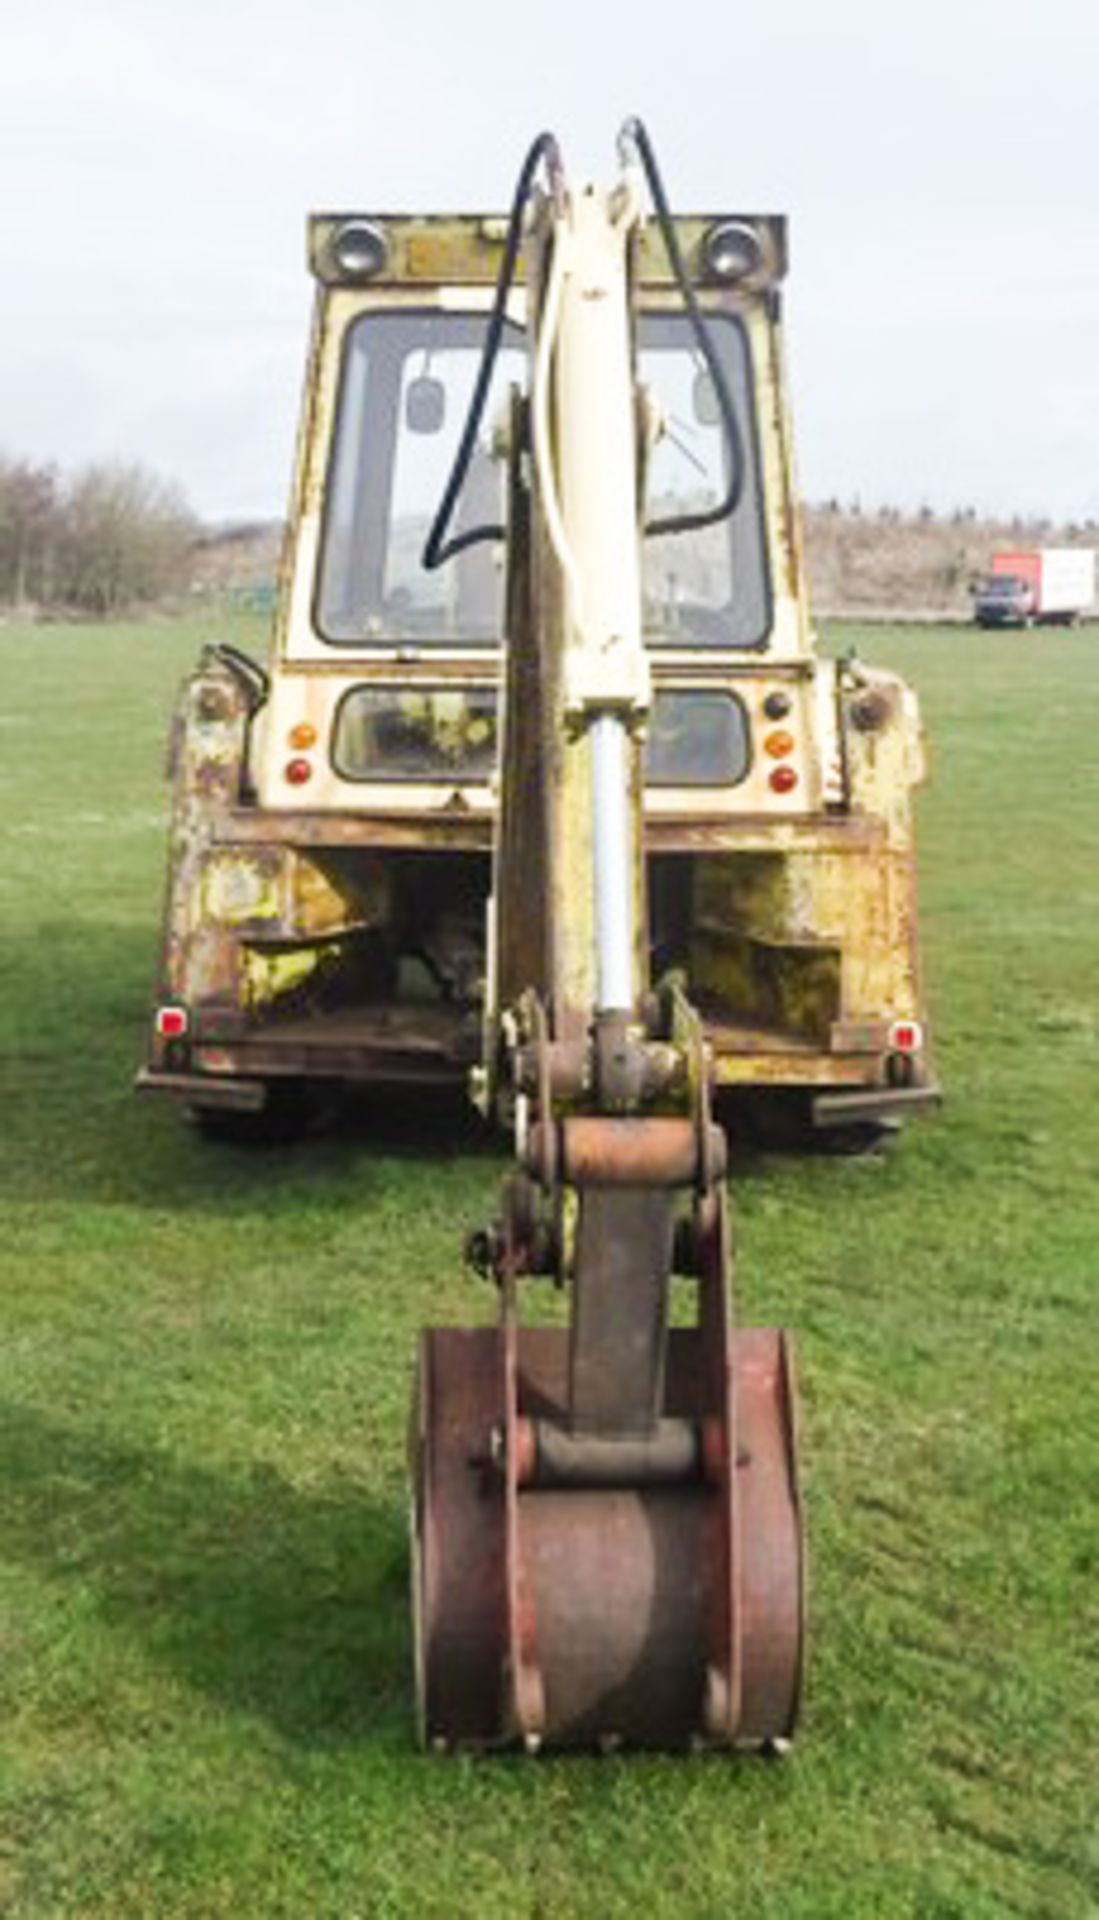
[194,503,1099,618]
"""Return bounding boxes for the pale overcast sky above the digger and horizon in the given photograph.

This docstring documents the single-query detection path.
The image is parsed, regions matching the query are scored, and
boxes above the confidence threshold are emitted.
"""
[0,0,1099,518]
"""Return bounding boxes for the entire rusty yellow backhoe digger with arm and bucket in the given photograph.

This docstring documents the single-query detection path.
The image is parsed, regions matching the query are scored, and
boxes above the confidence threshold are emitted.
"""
[142,119,934,1753]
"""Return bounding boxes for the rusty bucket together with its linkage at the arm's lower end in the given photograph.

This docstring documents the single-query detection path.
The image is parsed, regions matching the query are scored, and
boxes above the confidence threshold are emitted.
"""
[413,990,803,1751]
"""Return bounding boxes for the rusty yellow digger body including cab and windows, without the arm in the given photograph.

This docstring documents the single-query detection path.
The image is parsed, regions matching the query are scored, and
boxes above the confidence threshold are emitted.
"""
[138,213,934,1125]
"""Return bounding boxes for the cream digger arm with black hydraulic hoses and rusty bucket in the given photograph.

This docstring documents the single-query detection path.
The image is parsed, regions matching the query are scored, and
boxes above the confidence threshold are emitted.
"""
[413,123,801,1751]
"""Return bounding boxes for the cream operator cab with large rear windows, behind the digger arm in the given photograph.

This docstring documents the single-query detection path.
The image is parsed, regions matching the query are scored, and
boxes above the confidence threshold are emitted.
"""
[252,219,813,816]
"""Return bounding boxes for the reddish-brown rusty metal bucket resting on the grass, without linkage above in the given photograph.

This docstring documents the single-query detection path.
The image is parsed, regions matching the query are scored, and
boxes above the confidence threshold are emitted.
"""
[411,1320,803,1751]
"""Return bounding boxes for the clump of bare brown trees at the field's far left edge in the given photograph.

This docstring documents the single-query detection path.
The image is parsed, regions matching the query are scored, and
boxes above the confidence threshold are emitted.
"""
[0,455,198,618]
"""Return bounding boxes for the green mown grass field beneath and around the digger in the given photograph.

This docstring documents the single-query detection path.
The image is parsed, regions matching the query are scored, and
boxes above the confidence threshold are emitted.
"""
[0,624,1099,1920]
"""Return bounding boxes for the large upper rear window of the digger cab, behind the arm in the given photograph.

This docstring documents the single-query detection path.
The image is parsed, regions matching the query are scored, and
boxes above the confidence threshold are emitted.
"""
[315,309,770,649]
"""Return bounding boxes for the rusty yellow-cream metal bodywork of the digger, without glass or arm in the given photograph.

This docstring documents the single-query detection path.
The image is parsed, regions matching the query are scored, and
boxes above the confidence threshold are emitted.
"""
[152,215,930,1121]
